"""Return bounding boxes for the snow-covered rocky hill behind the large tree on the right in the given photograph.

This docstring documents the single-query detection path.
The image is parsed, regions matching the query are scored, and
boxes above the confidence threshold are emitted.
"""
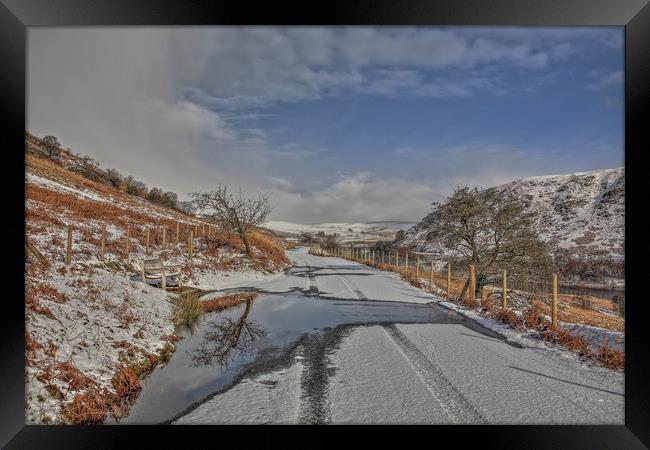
[399,167,625,258]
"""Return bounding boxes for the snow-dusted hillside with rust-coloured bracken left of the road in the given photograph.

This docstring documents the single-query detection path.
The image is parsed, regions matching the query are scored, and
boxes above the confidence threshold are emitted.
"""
[25,141,288,424]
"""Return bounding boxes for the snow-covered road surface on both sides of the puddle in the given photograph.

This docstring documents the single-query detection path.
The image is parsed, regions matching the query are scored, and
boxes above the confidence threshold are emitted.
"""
[174,250,624,424]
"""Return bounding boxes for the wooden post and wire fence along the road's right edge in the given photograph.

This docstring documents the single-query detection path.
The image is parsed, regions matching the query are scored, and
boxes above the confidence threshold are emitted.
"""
[312,246,625,326]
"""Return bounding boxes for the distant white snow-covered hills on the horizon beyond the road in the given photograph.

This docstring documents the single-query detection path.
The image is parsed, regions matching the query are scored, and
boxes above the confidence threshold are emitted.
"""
[264,221,414,243]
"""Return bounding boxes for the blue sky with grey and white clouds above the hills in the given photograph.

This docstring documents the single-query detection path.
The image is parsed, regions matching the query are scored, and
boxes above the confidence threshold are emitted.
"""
[27,27,624,223]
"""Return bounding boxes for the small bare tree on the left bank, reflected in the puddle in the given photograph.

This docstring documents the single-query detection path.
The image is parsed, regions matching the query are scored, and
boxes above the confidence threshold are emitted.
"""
[190,184,271,257]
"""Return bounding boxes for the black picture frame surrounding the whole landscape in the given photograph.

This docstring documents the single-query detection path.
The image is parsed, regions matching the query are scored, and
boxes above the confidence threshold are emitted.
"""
[0,0,650,449]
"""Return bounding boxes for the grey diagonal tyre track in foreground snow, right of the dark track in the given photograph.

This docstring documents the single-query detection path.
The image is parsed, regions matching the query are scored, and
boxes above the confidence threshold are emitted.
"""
[382,324,487,424]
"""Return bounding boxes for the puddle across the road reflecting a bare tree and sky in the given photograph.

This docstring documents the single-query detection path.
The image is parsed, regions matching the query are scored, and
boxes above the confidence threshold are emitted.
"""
[125,293,502,424]
